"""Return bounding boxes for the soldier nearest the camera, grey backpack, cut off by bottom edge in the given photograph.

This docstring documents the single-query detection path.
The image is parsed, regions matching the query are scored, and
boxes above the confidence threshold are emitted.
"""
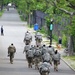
[39,62,50,75]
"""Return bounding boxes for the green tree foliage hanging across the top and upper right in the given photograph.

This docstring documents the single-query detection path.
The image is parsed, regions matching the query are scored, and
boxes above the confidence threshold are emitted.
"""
[4,0,75,53]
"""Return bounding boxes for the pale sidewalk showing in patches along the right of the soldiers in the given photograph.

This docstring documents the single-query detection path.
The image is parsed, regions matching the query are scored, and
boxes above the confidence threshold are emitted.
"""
[28,28,75,71]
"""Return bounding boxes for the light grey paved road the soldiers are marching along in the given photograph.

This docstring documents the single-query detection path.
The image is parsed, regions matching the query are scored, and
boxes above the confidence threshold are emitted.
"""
[0,8,75,75]
